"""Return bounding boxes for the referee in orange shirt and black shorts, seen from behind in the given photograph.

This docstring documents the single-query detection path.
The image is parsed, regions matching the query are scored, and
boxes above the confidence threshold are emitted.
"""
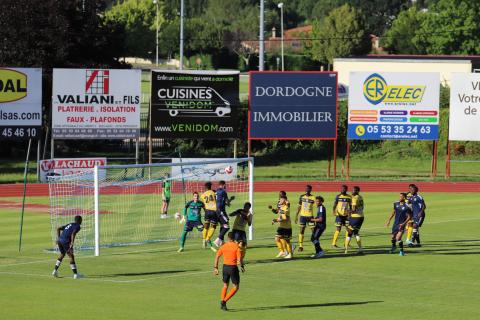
[213,232,245,311]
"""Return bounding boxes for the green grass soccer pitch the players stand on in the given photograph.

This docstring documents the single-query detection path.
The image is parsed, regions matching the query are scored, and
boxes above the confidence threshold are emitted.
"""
[0,193,480,320]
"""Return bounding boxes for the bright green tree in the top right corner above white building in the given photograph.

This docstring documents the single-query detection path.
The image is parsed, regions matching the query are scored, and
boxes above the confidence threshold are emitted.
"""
[412,0,480,54]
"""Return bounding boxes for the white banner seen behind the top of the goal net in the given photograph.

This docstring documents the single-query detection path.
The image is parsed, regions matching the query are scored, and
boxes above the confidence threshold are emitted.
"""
[172,158,237,181]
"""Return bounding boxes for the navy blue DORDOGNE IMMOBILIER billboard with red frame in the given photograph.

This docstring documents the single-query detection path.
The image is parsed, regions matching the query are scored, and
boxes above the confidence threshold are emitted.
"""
[248,72,338,140]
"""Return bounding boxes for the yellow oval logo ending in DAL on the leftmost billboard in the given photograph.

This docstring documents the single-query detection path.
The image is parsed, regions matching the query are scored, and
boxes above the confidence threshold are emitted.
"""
[0,69,27,103]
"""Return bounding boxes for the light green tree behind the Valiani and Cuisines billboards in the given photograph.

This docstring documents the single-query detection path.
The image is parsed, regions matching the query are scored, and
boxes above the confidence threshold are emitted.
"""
[105,0,164,57]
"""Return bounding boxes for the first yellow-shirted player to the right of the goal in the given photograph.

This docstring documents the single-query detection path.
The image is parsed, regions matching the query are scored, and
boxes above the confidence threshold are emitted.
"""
[270,195,293,259]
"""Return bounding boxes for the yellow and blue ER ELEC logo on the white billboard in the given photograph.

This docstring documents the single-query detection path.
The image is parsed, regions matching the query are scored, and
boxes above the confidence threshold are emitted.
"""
[363,73,425,105]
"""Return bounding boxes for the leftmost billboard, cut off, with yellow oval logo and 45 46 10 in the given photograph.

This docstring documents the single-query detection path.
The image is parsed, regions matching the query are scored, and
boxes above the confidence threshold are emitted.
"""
[0,68,42,139]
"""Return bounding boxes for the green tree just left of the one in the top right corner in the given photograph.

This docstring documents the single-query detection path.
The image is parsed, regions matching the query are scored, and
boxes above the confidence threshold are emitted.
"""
[382,6,426,54]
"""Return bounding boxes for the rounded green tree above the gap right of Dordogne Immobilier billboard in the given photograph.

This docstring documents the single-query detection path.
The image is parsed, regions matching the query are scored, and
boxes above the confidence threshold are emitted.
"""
[307,4,371,64]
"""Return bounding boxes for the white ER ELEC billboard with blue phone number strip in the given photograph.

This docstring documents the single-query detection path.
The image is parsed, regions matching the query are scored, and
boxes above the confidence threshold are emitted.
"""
[348,72,440,140]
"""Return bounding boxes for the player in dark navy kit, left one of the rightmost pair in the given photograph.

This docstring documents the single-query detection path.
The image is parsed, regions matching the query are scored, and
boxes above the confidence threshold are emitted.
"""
[386,192,412,256]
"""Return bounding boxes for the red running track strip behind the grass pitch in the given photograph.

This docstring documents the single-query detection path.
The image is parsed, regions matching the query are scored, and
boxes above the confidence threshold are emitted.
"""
[0,181,480,197]
